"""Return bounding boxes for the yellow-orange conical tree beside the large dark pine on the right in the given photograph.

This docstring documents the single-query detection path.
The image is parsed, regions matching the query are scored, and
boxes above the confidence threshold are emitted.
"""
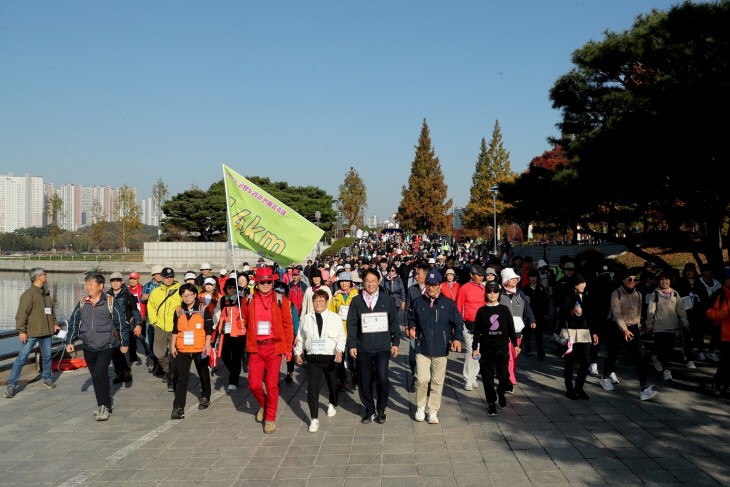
[462,120,517,230]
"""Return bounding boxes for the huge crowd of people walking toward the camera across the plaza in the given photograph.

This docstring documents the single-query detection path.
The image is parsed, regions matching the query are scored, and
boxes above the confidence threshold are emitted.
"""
[5,233,730,434]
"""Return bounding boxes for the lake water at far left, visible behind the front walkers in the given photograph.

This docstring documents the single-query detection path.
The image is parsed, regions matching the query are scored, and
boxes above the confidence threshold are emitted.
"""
[0,271,88,353]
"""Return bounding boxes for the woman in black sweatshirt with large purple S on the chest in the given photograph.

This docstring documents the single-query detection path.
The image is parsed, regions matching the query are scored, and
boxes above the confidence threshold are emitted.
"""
[472,281,520,416]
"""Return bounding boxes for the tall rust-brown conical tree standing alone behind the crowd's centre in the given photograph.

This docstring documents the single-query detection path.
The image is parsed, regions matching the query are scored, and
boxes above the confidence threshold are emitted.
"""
[396,118,452,232]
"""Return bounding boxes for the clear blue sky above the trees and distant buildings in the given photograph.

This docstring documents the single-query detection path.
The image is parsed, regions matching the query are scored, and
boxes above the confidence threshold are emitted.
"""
[0,0,677,222]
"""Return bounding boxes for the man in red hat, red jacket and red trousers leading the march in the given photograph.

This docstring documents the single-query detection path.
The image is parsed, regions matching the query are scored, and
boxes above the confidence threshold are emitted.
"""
[244,267,294,434]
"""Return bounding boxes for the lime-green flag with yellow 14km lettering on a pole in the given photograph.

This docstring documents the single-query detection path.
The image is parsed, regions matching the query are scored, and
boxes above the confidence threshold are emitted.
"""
[223,164,324,266]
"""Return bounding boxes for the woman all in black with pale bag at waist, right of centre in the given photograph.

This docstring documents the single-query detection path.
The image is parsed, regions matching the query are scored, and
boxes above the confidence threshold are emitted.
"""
[560,274,598,400]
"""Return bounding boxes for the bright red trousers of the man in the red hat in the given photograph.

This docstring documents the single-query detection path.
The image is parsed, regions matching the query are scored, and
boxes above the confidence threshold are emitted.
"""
[248,343,281,421]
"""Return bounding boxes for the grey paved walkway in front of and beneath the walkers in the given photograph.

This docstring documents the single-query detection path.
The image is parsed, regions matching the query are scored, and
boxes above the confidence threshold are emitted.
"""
[0,336,730,487]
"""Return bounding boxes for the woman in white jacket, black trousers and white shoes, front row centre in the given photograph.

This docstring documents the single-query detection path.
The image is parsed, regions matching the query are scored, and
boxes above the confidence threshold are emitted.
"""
[294,289,345,433]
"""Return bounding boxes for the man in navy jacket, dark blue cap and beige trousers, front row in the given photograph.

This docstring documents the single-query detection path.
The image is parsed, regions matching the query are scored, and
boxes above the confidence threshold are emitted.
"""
[408,271,464,424]
